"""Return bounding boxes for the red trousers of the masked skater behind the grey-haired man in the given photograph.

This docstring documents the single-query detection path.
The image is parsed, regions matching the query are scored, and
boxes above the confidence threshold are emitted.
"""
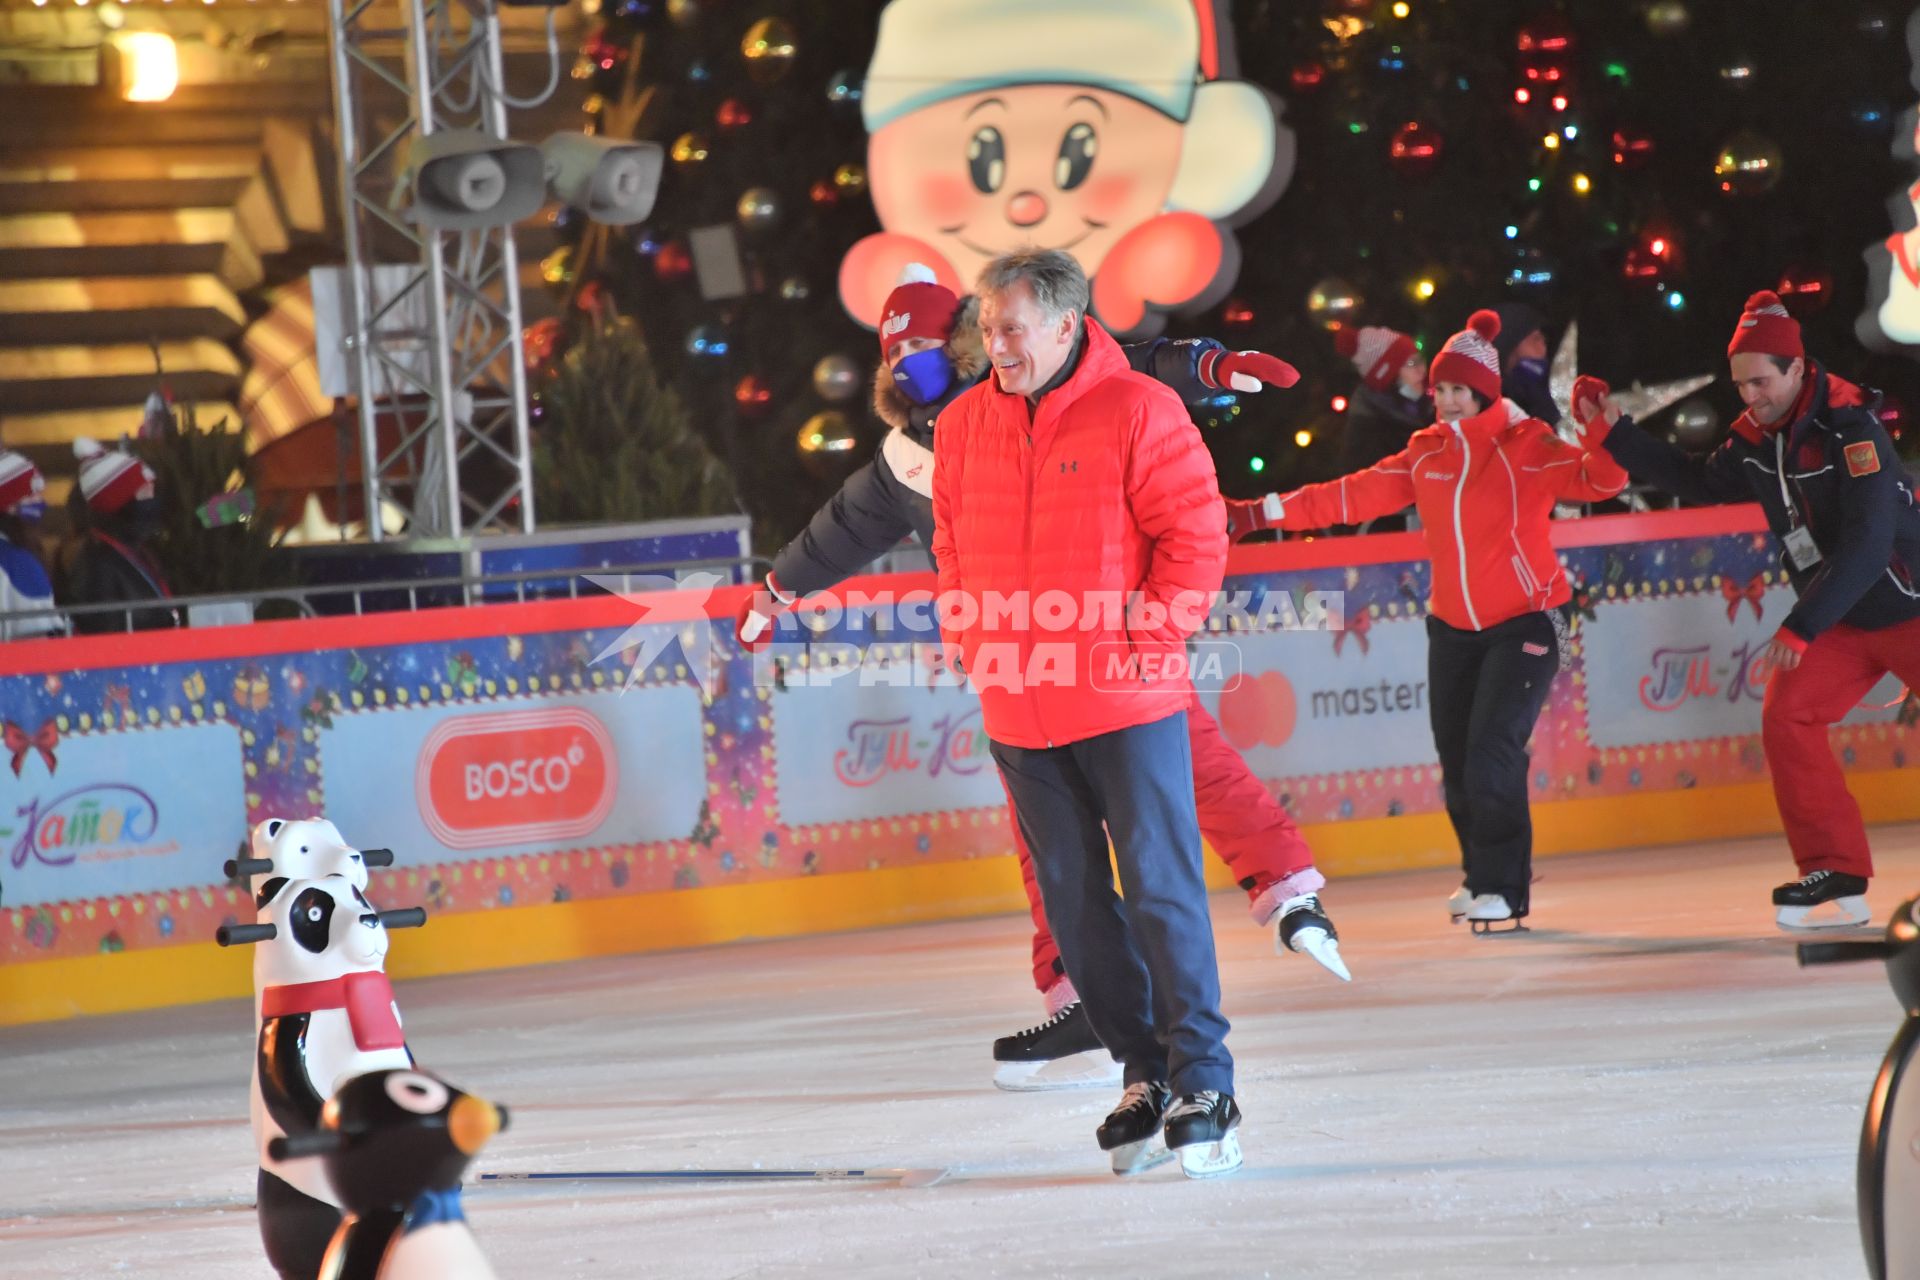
[1008,697,1313,992]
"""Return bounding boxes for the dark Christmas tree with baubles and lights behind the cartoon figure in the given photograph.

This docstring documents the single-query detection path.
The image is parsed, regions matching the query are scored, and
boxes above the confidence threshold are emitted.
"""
[541,0,1920,547]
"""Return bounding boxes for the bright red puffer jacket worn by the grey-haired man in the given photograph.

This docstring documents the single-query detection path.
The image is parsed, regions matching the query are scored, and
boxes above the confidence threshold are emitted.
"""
[933,320,1227,748]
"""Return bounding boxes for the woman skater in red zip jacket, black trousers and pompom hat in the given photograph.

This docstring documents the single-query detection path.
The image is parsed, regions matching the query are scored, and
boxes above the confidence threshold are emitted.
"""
[1236,311,1626,931]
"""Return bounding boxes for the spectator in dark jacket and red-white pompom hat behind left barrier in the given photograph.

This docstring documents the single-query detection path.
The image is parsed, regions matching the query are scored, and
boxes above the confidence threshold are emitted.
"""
[61,439,180,633]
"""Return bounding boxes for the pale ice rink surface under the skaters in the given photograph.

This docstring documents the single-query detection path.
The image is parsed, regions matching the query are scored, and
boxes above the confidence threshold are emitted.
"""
[0,827,1920,1280]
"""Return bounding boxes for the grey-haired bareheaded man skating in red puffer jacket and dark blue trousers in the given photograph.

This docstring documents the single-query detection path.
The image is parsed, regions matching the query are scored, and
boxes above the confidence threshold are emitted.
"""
[933,249,1240,1176]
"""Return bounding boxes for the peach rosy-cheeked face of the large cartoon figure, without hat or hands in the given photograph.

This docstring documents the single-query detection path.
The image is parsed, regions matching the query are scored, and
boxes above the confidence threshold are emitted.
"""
[868,84,1185,280]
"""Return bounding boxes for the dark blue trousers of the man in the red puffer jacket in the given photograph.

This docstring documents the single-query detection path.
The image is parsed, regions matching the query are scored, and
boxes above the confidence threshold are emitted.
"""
[993,712,1233,1094]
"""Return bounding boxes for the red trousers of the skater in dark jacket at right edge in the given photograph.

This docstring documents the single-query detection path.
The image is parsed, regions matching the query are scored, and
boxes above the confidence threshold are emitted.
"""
[1761,618,1920,877]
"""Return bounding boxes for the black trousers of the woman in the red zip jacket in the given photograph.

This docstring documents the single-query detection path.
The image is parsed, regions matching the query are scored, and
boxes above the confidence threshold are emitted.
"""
[1427,612,1559,915]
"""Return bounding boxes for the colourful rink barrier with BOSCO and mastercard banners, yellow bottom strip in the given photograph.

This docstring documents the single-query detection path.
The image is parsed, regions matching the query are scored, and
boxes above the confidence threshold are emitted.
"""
[0,507,1920,1025]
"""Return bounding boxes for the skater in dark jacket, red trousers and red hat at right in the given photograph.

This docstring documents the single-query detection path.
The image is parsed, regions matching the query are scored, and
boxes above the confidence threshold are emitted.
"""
[1574,292,1920,929]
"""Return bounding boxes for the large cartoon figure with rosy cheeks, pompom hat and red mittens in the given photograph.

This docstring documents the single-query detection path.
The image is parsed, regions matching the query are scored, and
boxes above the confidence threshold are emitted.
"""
[841,0,1292,336]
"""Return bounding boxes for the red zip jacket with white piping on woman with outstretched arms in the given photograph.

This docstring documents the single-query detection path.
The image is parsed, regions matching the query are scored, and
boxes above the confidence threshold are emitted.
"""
[1279,401,1626,631]
